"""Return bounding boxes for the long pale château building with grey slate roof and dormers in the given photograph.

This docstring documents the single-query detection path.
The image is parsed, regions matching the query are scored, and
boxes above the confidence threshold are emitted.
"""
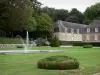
[54,20,100,42]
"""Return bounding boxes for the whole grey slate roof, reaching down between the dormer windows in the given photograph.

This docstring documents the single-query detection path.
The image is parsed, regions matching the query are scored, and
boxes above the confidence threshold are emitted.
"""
[54,20,100,33]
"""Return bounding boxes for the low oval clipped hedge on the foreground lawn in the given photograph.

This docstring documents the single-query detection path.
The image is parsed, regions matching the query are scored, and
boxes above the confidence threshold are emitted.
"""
[37,56,79,70]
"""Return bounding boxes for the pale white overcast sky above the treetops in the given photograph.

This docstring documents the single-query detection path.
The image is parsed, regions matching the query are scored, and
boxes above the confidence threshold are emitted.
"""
[38,0,100,12]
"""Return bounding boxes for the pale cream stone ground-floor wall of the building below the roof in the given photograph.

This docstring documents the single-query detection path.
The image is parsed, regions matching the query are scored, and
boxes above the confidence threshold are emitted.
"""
[55,32,100,42]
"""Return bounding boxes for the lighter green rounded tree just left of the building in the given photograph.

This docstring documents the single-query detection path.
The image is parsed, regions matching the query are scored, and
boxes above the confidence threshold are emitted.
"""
[37,13,53,36]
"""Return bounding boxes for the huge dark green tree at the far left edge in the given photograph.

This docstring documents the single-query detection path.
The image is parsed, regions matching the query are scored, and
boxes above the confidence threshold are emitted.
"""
[0,0,32,34]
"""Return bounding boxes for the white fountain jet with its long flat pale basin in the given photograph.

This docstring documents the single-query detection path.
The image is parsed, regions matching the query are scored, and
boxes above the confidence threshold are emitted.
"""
[0,31,67,54]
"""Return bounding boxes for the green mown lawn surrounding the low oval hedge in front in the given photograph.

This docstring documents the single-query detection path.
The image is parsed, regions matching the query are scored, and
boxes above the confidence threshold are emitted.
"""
[0,47,100,75]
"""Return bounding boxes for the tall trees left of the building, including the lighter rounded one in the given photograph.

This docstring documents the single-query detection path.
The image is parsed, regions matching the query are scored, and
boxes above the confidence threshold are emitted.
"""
[0,0,53,37]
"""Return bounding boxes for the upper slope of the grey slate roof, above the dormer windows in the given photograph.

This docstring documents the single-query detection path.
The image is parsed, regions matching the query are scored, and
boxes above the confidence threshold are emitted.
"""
[54,20,100,29]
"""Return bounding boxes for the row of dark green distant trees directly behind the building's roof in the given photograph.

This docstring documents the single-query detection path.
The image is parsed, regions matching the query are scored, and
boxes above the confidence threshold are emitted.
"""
[42,7,84,23]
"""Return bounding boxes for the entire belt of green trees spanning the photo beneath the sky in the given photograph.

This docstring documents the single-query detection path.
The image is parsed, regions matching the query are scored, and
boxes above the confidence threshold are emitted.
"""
[0,0,100,38]
